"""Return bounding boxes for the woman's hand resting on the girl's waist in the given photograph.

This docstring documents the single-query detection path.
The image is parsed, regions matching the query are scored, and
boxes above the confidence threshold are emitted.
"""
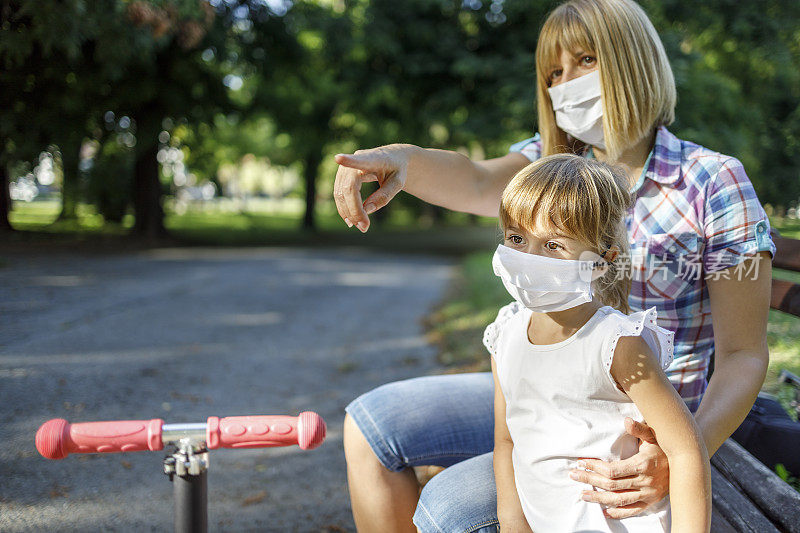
[570,418,669,519]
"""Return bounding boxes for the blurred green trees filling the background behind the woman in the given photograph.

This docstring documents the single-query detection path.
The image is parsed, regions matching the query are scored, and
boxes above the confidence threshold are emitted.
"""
[0,0,800,238]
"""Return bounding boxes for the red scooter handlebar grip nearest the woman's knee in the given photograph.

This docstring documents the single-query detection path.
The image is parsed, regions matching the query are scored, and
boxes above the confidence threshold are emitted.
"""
[206,411,326,450]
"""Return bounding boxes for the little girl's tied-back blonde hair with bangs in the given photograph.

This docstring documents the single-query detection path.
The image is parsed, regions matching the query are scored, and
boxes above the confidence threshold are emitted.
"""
[500,154,631,314]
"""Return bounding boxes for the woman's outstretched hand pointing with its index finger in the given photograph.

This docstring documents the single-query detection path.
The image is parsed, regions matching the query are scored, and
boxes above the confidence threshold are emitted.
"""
[333,144,415,233]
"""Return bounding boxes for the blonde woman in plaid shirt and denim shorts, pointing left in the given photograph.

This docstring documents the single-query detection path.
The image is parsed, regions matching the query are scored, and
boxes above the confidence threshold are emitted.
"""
[334,0,775,532]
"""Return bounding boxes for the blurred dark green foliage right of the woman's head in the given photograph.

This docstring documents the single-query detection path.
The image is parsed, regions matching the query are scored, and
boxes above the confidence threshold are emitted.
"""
[642,0,800,207]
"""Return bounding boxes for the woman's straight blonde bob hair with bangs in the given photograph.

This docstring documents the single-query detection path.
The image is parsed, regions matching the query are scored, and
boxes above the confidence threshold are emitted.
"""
[536,0,676,161]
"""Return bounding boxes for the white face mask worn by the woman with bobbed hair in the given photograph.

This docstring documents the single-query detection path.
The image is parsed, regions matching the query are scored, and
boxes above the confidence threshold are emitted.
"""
[547,70,606,150]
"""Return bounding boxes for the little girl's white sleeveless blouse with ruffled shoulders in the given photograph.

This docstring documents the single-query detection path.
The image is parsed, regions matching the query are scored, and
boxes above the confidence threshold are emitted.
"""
[483,302,674,533]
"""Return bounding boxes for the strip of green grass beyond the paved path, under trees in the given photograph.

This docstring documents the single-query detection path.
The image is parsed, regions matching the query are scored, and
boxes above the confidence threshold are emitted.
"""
[8,200,496,255]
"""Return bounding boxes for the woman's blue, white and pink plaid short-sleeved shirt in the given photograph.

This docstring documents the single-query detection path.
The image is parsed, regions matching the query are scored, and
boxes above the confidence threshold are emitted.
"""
[510,126,775,412]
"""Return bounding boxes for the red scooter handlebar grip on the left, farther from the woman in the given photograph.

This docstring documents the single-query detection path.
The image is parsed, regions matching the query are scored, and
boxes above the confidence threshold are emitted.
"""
[36,418,164,459]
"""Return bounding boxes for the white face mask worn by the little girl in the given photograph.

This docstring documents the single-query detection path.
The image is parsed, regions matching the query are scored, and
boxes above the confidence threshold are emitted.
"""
[492,244,594,313]
